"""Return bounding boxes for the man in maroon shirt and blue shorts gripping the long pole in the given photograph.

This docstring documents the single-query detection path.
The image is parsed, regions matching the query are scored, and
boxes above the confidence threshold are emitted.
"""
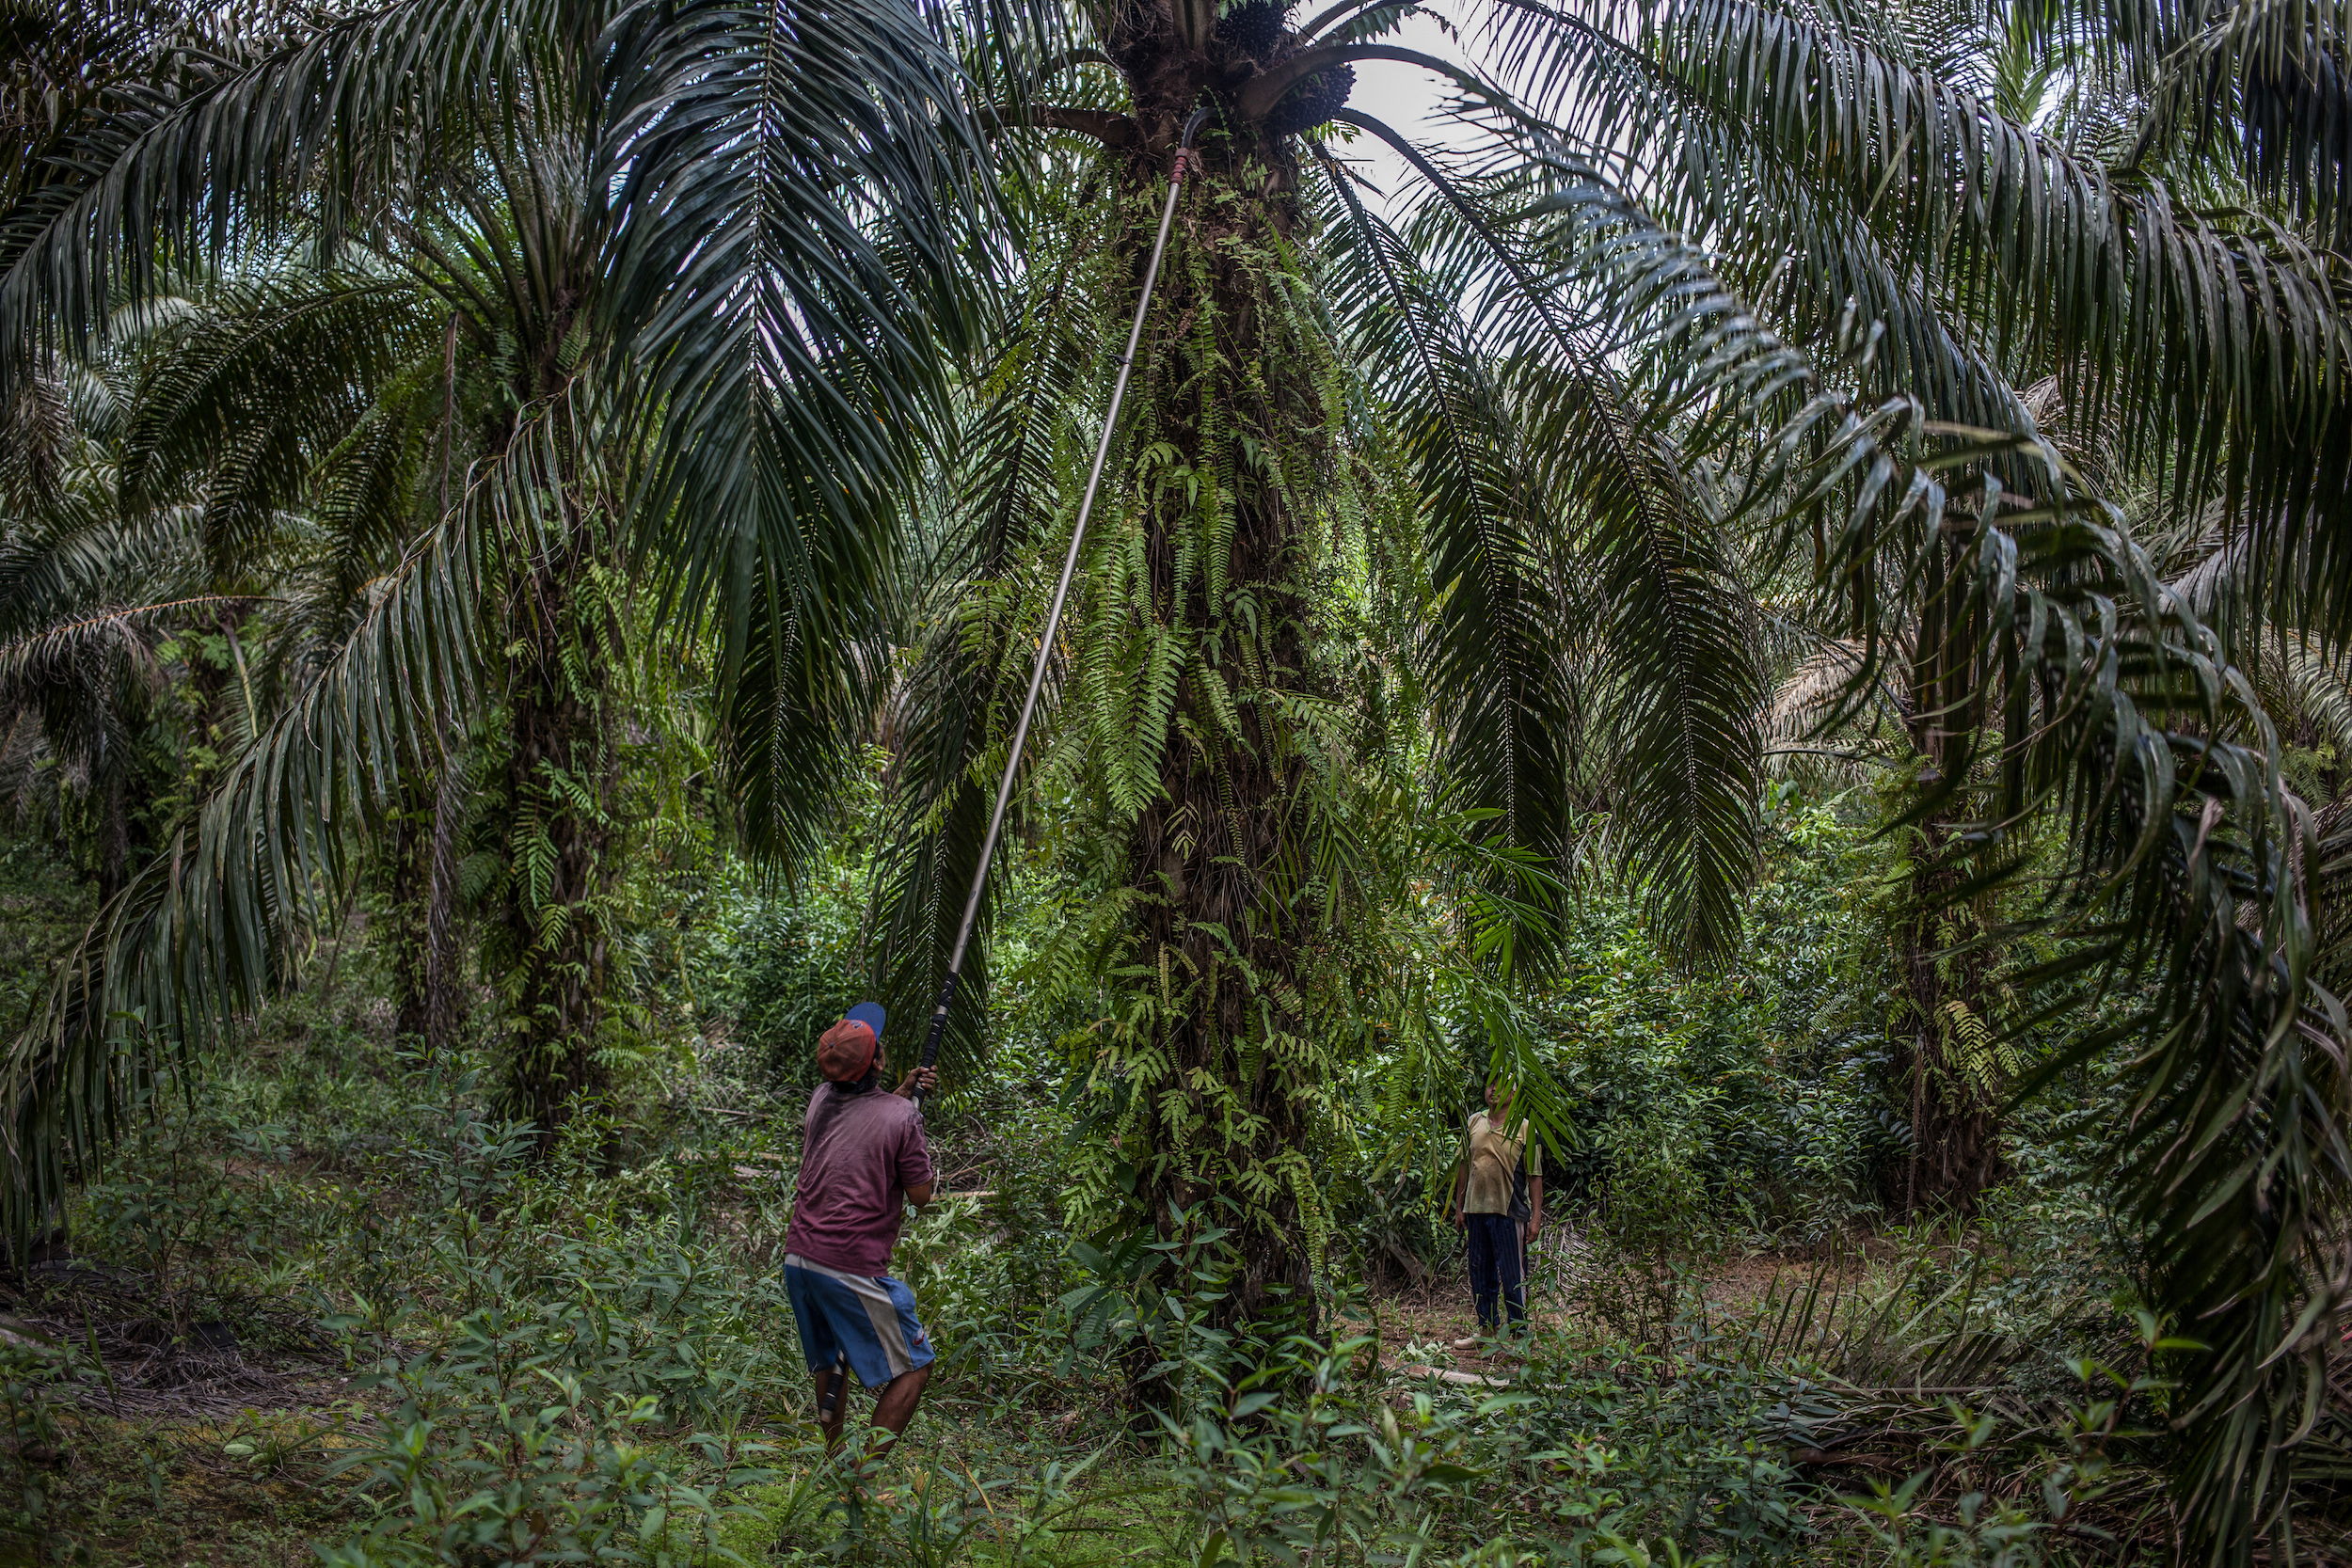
[784,1002,934,1460]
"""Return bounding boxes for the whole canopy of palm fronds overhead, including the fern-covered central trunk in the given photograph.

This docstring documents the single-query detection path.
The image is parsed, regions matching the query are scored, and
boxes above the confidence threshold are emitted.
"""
[0,0,2352,1559]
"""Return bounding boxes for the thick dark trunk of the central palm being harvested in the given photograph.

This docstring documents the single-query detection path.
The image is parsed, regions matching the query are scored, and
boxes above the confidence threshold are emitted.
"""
[1127,125,1329,1354]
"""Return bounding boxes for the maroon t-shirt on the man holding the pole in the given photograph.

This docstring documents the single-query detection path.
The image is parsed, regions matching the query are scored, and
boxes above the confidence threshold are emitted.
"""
[784,1084,931,1276]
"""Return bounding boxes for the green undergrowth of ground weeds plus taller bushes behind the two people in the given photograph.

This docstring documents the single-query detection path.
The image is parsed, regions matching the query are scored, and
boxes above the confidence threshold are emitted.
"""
[0,818,2338,1568]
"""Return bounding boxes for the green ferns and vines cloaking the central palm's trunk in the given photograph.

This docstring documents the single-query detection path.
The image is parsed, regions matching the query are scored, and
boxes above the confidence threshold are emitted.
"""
[1077,141,1362,1363]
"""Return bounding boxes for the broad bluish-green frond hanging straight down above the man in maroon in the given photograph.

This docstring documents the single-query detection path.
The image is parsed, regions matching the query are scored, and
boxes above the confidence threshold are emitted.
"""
[600,2,993,869]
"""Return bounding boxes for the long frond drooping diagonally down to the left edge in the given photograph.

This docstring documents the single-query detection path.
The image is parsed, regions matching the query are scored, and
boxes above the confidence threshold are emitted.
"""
[0,385,581,1234]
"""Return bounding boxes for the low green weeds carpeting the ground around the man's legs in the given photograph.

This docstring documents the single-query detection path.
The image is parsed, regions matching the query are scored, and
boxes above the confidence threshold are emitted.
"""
[0,921,2296,1568]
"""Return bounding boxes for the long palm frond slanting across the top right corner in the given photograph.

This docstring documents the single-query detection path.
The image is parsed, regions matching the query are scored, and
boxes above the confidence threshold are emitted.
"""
[1508,0,2352,632]
